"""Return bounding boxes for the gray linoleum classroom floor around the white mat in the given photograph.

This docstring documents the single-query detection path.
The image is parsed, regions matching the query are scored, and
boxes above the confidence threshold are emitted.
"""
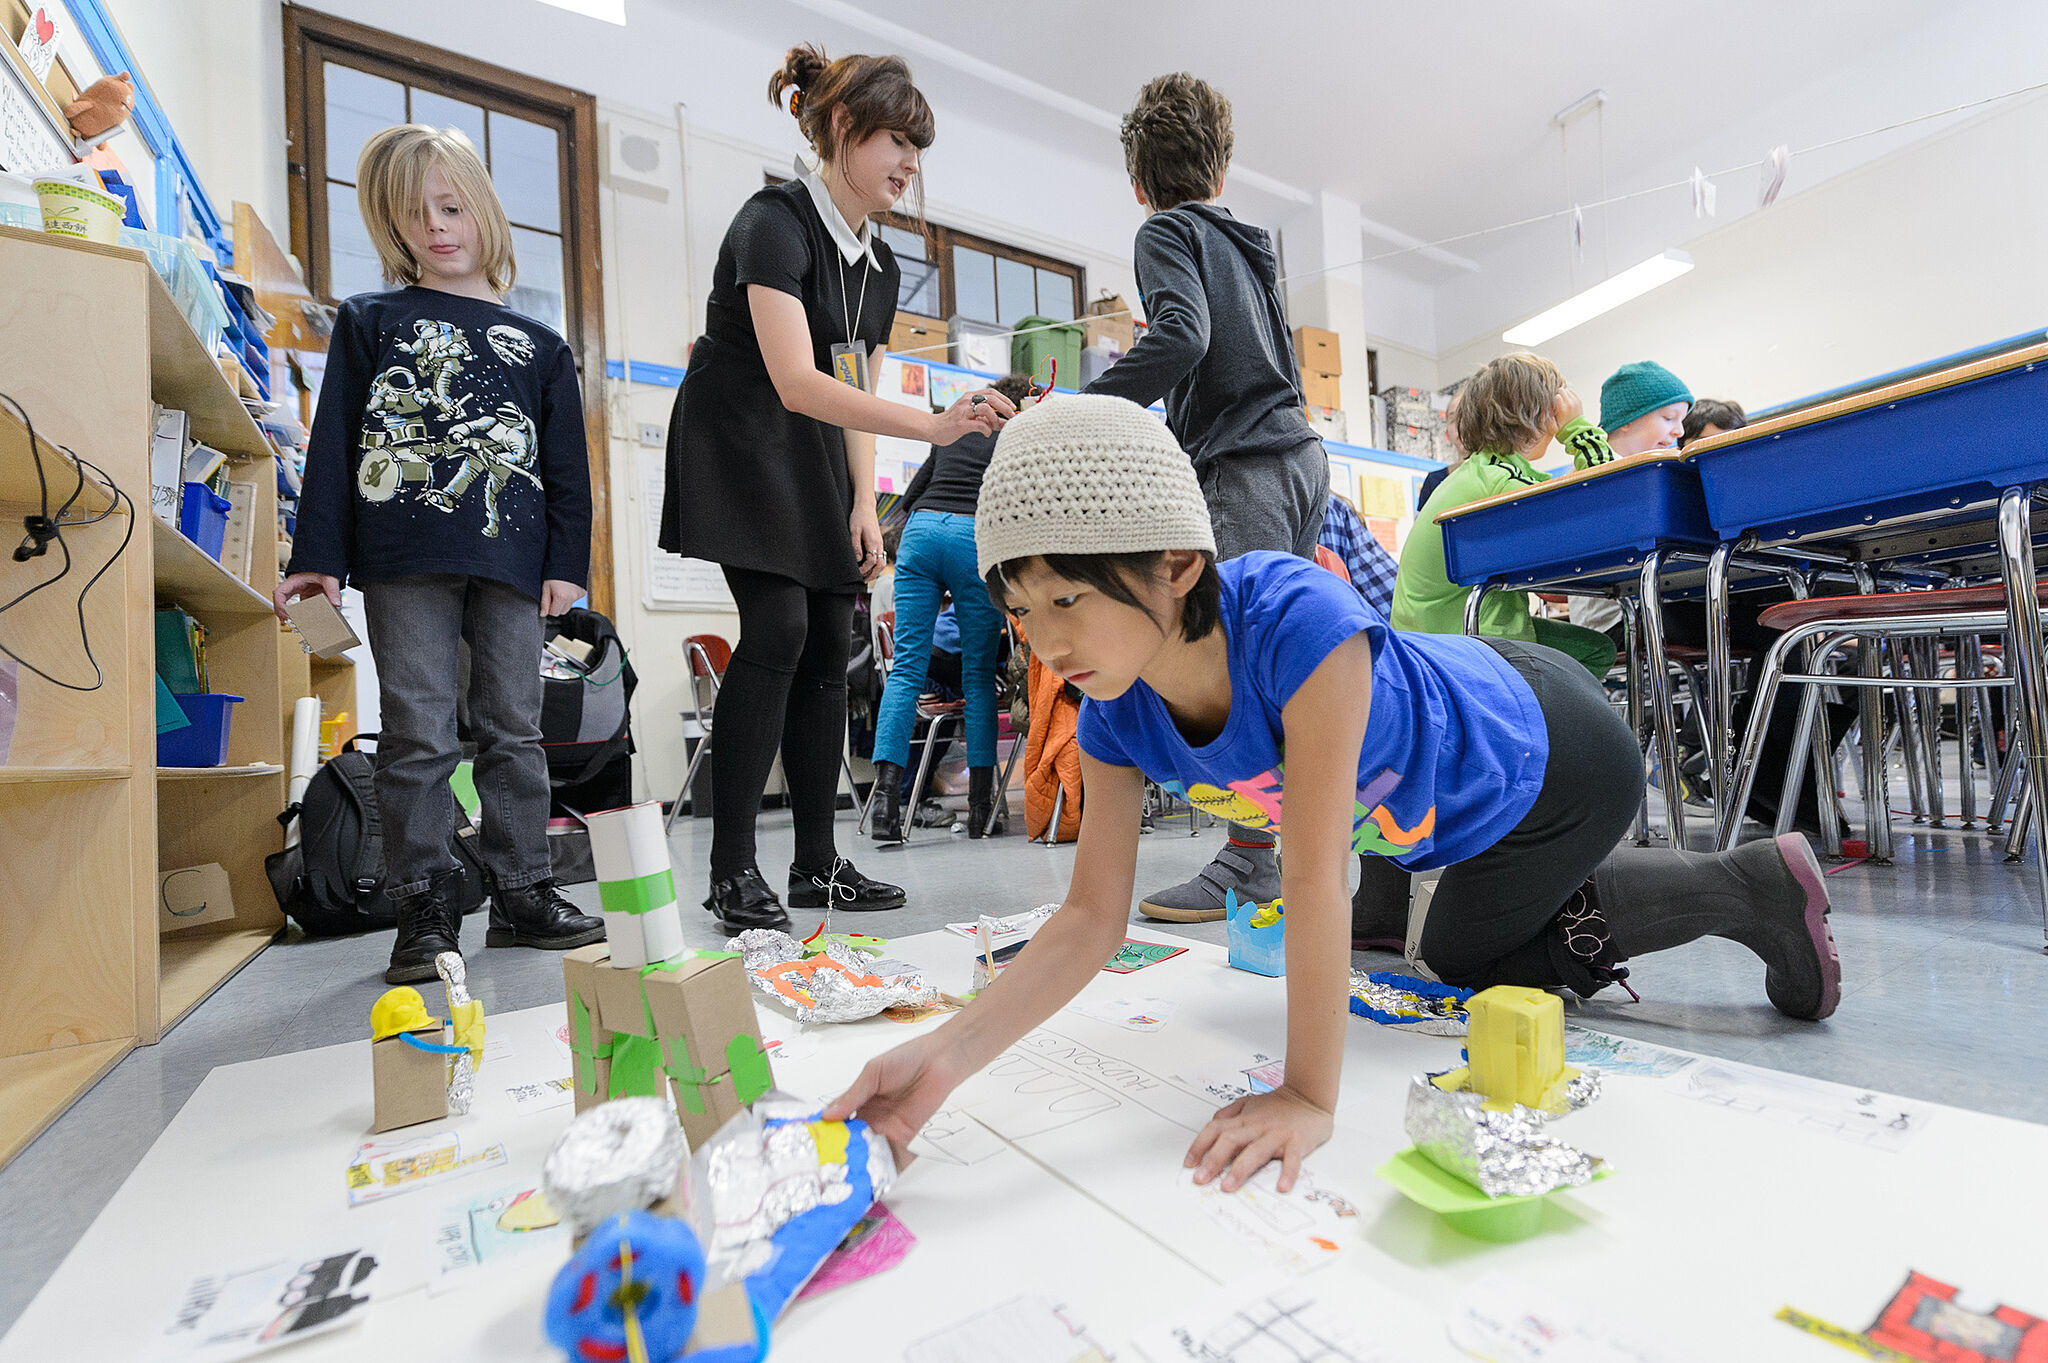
[0,772,2048,1328]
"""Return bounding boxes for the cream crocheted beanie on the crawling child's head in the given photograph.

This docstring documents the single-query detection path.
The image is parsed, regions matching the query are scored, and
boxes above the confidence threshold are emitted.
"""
[975,393,1217,577]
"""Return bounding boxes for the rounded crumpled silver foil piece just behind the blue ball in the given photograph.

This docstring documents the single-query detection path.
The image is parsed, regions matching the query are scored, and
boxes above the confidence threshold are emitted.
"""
[541,1097,690,1236]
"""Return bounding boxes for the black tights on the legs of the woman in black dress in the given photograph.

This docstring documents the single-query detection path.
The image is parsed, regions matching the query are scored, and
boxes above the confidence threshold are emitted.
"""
[711,567,854,882]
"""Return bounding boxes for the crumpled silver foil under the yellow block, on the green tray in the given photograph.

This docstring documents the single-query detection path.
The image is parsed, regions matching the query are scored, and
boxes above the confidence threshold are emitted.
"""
[1405,1074,1602,1197]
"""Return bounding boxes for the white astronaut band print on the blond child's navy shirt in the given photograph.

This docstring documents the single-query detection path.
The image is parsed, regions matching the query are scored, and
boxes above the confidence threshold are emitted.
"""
[356,317,543,538]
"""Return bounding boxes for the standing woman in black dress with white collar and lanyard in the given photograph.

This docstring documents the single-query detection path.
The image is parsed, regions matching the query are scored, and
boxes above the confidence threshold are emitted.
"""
[662,47,1014,933]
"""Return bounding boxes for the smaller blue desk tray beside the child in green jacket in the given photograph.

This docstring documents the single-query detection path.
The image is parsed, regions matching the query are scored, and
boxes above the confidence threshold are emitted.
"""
[1444,458,1718,587]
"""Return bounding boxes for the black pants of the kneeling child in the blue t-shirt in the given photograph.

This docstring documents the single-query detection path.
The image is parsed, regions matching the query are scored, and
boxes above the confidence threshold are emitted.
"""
[1360,639,1642,988]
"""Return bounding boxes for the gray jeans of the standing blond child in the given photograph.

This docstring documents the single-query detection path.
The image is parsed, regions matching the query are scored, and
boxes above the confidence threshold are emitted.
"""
[362,573,551,898]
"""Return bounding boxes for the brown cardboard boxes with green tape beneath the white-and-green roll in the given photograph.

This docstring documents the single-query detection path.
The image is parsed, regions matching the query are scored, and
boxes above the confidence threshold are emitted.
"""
[561,943,774,1148]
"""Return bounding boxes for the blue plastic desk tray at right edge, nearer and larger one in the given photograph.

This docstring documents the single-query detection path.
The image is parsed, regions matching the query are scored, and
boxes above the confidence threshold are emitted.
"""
[1688,347,2048,544]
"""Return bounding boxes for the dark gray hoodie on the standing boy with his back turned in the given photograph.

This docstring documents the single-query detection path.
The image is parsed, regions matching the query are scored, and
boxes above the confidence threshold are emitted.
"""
[1087,203,1317,469]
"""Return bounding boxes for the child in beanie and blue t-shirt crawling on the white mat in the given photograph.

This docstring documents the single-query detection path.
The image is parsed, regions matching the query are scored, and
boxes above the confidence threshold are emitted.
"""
[825,397,1841,1191]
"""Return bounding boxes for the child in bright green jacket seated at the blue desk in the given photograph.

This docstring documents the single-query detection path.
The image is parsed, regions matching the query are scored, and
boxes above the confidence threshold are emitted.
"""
[1393,350,1616,677]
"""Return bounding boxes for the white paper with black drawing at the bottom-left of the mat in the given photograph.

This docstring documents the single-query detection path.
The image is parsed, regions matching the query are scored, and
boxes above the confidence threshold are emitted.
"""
[150,1236,383,1363]
